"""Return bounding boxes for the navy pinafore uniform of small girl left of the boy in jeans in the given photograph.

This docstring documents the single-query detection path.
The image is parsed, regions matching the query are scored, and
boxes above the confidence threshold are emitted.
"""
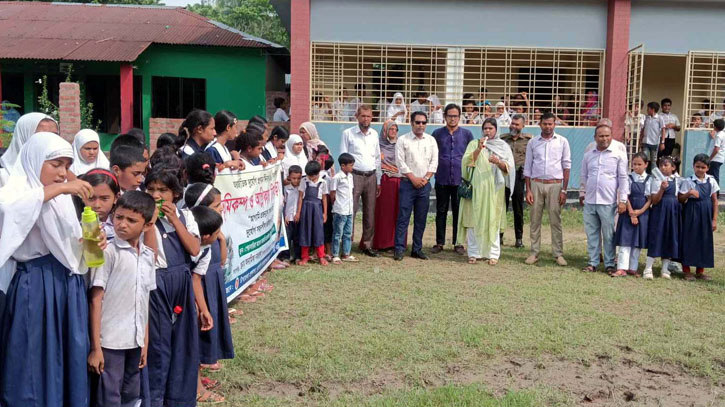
[297,178,327,247]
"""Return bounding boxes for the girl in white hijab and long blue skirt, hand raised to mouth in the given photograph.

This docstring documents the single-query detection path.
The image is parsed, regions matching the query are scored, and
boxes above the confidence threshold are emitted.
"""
[0,132,94,407]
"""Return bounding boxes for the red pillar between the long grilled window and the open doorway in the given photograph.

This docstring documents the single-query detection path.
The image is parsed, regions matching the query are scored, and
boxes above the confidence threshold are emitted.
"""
[602,0,632,141]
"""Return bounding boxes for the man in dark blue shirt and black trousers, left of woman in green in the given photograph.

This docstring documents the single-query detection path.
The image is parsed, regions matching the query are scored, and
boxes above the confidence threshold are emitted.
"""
[431,103,473,255]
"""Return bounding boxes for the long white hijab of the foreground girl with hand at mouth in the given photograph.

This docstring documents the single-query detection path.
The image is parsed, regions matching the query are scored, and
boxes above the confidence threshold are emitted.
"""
[0,132,82,291]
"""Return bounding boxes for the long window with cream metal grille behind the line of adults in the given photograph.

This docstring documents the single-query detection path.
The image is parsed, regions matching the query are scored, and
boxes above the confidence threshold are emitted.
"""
[311,42,604,126]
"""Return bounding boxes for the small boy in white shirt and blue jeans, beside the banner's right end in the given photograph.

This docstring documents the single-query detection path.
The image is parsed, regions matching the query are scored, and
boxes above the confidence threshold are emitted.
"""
[330,153,358,264]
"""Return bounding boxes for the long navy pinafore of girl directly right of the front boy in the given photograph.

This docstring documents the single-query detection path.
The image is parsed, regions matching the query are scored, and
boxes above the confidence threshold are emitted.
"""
[148,213,199,407]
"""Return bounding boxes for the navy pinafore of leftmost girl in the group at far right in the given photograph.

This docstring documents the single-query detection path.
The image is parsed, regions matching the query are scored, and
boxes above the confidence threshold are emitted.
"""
[614,174,650,249]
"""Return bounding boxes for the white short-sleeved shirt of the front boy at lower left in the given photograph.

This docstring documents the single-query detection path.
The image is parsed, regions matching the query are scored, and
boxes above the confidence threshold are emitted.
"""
[91,239,156,350]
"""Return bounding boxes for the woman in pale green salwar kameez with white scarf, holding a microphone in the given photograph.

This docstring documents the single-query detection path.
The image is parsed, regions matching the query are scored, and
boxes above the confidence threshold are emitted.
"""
[458,119,516,265]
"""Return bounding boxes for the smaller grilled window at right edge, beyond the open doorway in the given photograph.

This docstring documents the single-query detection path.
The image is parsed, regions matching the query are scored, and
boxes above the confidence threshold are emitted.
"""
[683,51,725,129]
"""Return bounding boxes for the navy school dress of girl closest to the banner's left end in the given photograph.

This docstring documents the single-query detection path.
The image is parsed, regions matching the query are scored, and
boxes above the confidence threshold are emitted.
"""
[199,240,234,365]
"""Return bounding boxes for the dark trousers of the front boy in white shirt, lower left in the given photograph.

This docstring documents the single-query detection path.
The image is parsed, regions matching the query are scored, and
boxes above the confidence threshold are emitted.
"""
[91,348,141,407]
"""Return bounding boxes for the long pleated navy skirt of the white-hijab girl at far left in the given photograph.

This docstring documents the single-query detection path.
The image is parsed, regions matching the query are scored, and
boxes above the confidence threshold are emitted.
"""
[0,255,90,407]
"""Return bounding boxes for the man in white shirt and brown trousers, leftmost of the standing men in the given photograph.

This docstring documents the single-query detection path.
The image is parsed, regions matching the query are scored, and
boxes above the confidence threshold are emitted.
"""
[340,105,382,257]
